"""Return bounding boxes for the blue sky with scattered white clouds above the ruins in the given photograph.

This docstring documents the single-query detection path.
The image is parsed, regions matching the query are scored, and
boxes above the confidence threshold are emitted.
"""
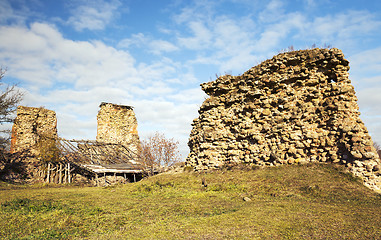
[0,0,381,158]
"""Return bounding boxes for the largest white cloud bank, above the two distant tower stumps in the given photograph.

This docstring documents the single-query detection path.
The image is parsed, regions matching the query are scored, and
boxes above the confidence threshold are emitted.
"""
[0,23,140,88]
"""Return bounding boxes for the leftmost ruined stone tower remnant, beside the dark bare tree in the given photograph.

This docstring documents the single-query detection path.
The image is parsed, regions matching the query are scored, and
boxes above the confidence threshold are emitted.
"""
[11,106,57,155]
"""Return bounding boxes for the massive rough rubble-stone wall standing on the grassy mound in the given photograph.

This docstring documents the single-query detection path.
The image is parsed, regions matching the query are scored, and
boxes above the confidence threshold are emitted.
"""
[186,49,381,190]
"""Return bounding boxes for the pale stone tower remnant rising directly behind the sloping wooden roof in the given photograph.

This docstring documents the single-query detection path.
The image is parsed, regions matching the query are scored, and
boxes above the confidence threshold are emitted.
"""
[97,103,140,152]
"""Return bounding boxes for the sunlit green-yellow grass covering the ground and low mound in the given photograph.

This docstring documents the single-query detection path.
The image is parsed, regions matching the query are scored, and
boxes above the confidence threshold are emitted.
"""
[0,165,381,239]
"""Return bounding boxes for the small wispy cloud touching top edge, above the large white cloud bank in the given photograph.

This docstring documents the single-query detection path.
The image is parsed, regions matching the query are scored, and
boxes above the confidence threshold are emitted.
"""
[67,0,121,31]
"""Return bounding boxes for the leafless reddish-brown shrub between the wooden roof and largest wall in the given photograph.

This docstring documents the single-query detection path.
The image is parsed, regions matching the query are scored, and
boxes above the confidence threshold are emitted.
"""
[140,132,180,175]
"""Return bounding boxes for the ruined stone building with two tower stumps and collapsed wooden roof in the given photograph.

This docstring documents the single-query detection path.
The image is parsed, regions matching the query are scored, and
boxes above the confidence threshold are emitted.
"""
[7,103,141,183]
